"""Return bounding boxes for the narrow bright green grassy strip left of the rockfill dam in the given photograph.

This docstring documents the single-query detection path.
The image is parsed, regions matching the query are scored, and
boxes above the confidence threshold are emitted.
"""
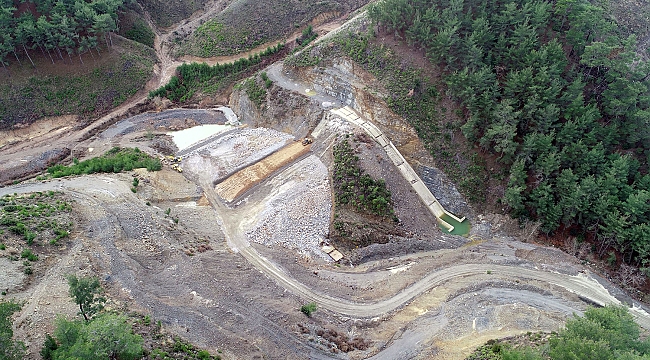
[47,147,162,182]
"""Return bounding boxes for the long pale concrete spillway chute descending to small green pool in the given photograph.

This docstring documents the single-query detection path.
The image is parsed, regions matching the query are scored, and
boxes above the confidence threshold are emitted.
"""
[330,106,465,232]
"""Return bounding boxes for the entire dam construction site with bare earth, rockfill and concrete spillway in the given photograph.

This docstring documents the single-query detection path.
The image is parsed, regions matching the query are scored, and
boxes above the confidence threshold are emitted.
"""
[0,14,650,359]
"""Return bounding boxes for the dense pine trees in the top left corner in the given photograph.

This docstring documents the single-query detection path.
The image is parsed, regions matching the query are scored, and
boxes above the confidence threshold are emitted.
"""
[0,0,123,69]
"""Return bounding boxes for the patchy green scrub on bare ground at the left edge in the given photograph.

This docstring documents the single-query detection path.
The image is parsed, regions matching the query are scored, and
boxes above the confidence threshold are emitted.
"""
[0,191,72,248]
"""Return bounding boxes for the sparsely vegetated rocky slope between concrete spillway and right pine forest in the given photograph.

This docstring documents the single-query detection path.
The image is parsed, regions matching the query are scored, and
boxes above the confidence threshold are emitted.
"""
[285,31,488,205]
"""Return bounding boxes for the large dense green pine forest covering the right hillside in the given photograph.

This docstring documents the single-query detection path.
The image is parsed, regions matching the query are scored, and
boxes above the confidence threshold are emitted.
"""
[370,0,650,266]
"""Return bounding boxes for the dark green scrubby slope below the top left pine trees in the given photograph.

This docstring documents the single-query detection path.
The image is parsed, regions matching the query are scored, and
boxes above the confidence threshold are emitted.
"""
[0,36,156,129]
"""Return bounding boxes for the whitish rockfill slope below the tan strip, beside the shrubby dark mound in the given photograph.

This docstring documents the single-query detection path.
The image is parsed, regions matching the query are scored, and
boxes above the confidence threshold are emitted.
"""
[246,156,332,260]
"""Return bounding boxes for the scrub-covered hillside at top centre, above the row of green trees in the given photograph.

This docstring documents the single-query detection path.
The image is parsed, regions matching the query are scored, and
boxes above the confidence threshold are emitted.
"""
[177,0,367,57]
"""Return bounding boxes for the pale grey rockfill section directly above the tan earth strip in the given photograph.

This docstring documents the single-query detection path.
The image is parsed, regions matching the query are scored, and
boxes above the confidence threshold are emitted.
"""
[182,128,293,182]
